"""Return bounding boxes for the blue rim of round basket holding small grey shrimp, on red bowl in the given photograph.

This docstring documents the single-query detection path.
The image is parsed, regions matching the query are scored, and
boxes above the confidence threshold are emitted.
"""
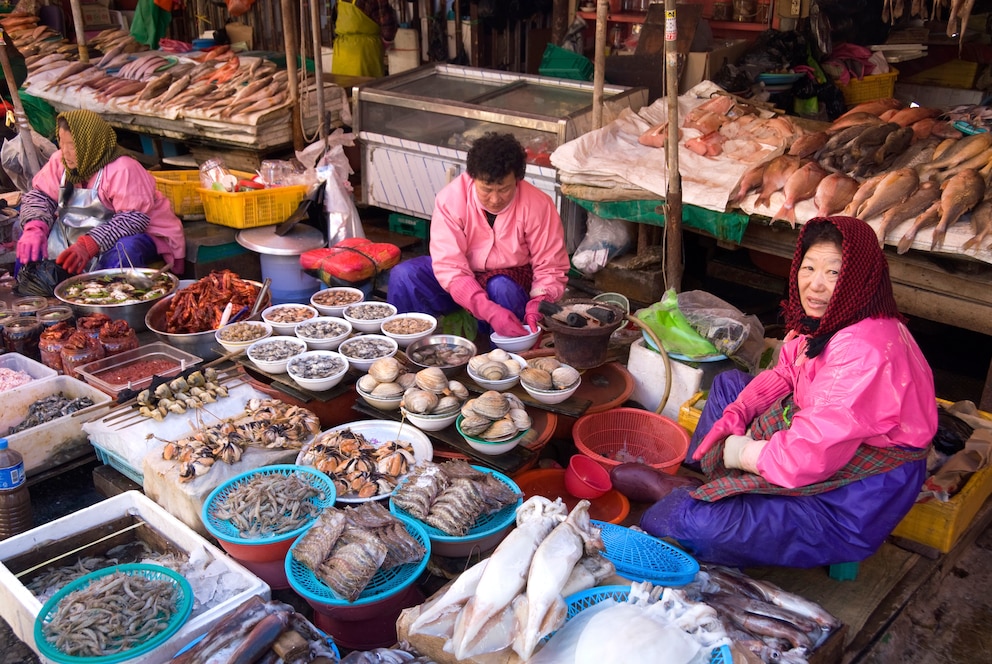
[200,464,337,545]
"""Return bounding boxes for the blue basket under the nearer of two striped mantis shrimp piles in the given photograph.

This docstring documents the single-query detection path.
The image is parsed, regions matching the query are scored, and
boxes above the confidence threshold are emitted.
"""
[286,515,431,607]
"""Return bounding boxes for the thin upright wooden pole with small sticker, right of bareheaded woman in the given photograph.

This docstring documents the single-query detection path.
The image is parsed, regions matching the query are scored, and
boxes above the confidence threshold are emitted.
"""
[664,0,683,291]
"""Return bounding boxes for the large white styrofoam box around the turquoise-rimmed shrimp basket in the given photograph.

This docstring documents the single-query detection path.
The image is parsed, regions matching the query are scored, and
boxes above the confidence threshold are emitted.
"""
[0,491,271,664]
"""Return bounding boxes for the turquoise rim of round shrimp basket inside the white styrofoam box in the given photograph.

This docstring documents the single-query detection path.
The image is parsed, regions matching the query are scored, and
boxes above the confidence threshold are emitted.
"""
[34,563,193,664]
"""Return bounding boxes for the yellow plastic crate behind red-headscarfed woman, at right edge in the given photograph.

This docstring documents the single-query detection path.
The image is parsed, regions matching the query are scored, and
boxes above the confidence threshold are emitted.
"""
[892,399,992,553]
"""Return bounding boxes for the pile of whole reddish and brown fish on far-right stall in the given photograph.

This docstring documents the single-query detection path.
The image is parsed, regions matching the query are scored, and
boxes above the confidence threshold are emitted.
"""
[730,99,992,253]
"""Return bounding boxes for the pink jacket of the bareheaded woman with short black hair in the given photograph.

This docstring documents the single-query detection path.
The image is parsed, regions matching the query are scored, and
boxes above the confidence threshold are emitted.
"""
[430,173,569,302]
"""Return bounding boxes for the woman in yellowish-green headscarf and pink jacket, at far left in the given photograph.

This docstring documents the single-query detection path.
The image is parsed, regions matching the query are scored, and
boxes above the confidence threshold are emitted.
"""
[17,110,186,274]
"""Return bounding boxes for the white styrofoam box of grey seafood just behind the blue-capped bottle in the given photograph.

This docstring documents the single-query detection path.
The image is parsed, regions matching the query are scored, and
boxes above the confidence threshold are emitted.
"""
[0,376,110,477]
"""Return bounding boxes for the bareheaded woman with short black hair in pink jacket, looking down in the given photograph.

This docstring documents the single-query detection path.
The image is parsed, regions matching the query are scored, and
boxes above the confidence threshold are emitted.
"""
[387,133,569,337]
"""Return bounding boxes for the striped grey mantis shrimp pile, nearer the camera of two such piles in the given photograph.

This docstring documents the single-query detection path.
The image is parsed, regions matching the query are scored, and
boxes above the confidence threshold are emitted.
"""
[292,501,427,602]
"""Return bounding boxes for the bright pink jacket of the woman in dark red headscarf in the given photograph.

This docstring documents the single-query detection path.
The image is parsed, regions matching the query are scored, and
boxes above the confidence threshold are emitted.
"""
[757,318,937,487]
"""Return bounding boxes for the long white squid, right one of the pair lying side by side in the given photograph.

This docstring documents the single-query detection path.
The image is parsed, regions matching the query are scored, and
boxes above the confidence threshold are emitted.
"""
[513,500,603,661]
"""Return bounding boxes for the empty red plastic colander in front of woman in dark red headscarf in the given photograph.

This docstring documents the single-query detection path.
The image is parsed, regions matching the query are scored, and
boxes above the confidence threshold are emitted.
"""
[572,408,689,475]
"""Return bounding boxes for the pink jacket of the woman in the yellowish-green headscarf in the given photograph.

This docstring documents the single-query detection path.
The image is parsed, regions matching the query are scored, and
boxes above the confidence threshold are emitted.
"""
[32,150,186,270]
